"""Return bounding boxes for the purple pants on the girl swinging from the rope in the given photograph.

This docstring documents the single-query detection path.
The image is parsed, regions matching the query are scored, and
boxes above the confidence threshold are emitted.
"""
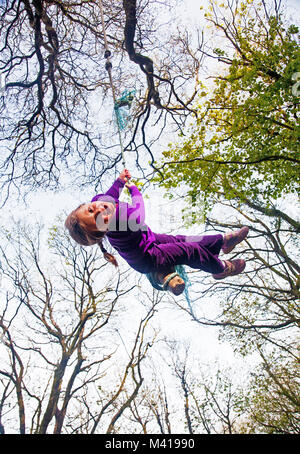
[132,233,224,274]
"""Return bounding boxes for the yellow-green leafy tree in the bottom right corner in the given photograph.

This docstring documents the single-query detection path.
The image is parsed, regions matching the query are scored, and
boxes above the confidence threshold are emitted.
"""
[241,345,300,434]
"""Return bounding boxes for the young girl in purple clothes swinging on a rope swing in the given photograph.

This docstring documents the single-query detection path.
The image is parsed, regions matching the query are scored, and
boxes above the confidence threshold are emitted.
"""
[65,169,249,295]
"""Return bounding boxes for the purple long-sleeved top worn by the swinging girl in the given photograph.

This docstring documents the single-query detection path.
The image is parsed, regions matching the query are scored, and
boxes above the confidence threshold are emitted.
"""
[92,178,155,272]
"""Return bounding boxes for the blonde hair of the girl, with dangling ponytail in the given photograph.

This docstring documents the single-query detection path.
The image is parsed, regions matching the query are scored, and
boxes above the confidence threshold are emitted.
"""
[65,203,118,267]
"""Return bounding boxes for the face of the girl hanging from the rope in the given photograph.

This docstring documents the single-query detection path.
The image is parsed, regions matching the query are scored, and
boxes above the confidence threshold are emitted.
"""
[77,200,116,233]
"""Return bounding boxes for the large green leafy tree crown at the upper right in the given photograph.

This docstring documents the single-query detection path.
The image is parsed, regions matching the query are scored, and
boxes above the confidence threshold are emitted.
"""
[157,0,300,203]
